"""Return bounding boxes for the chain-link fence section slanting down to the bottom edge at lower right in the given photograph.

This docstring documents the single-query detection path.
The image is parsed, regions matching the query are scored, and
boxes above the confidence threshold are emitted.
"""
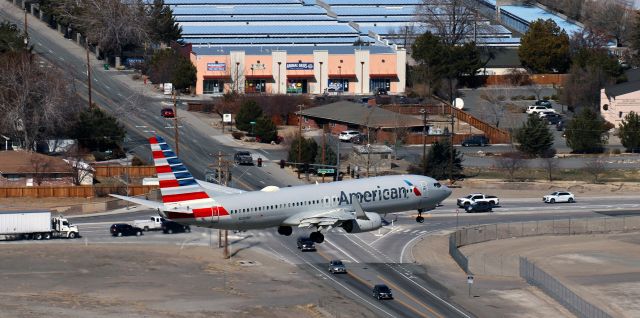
[520,257,612,318]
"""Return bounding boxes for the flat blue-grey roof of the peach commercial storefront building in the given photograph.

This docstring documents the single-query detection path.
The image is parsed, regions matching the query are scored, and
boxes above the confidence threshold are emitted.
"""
[192,45,395,55]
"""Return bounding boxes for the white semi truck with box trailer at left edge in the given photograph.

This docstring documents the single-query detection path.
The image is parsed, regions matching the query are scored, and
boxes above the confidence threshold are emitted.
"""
[0,211,80,240]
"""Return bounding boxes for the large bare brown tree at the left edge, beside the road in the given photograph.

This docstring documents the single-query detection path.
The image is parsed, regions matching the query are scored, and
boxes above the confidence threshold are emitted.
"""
[0,53,80,150]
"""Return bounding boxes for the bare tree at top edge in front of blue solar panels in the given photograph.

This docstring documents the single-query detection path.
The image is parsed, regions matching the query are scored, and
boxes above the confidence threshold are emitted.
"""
[417,0,485,46]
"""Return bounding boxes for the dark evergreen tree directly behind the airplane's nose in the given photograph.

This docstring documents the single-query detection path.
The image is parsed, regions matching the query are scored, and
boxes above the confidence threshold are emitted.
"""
[420,140,463,180]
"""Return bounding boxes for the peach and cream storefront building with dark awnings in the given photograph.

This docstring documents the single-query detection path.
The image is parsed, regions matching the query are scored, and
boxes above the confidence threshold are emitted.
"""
[191,46,407,95]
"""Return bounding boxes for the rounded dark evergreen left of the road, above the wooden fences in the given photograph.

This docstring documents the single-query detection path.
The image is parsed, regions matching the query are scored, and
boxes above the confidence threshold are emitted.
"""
[69,107,125,152]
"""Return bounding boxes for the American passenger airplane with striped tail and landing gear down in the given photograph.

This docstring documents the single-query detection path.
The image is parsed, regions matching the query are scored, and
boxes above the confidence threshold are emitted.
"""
[111,136,451,243]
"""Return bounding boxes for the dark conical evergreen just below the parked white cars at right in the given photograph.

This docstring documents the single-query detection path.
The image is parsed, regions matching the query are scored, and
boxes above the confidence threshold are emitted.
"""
[515,114,553,157]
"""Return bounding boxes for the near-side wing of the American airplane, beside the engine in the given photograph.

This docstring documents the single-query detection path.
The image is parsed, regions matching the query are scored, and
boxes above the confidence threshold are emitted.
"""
[282,208,356,229]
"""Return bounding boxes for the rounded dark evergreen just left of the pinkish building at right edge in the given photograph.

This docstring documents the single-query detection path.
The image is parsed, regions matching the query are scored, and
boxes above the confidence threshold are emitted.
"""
[565,108,609,153]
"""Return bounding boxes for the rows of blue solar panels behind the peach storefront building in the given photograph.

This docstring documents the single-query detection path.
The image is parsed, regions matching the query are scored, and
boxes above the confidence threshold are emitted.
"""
[165,0,519,46]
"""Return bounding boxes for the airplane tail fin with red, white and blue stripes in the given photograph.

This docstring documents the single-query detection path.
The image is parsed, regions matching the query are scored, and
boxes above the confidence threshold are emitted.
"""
[149,136,218,218]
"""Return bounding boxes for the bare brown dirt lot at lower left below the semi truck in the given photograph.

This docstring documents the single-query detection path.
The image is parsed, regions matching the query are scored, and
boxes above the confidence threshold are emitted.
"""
[0,242,373,318]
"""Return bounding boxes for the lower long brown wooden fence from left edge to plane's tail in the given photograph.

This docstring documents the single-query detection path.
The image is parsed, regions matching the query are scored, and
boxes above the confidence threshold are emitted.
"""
[0,185,158,198]
